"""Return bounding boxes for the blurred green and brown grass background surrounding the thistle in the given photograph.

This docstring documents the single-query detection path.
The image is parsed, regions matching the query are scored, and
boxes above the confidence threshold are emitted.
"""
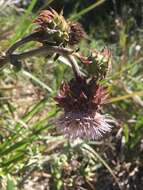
[0,0,143,190]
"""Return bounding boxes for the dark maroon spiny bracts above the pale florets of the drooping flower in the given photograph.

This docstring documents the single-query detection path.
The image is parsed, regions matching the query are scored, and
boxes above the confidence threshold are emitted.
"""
[55,77,108,113]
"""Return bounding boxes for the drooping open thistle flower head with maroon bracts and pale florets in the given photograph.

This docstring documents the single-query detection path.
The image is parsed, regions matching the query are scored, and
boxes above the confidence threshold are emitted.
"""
[55,78,111,139]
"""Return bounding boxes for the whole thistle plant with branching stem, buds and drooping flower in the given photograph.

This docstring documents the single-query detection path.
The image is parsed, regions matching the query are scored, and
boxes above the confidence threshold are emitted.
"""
[0,9,111,140]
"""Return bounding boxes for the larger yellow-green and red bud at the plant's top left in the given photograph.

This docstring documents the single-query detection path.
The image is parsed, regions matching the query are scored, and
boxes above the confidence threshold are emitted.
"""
[33,9,69,45]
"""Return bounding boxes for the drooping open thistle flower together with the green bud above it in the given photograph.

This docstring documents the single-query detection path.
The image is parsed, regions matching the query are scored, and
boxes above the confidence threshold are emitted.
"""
[55,49,111,140]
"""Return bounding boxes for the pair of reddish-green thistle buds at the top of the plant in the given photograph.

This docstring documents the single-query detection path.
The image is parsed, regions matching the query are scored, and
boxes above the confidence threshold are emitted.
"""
[33,9,85,46]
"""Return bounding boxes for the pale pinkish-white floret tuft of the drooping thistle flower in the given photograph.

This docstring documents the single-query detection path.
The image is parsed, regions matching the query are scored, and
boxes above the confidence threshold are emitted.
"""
[57,111,111,140]
